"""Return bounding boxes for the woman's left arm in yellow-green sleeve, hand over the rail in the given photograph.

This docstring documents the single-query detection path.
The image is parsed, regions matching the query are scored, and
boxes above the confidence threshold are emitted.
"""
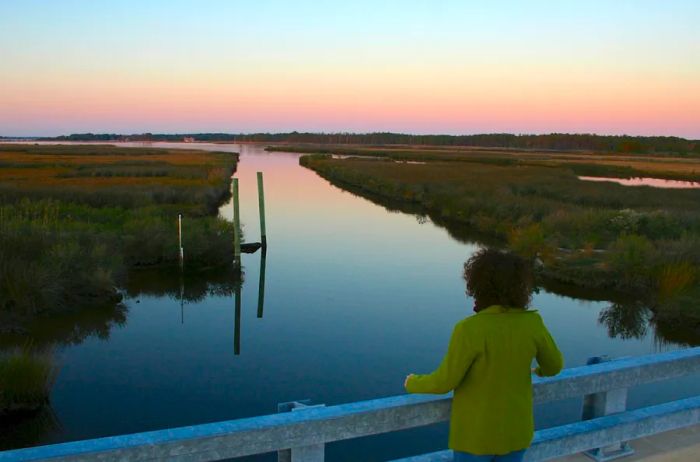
[404,324,476,393]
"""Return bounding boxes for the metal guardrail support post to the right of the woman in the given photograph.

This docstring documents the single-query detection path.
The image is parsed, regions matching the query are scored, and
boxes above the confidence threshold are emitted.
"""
[581,356,634,462]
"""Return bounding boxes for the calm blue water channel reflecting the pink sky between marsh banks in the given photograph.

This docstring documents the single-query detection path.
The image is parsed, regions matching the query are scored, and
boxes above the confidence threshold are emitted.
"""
[2,143,700,461]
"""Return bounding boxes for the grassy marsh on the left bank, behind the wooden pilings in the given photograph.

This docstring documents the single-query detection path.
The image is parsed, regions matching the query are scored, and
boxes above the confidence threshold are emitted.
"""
[0,145,237,327]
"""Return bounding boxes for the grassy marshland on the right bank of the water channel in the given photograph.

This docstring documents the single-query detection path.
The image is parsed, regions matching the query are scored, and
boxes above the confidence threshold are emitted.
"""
[300,150,700,338]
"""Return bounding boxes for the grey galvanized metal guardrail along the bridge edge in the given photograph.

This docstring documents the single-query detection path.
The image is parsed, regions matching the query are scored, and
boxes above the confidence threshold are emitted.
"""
[0,348,700,462]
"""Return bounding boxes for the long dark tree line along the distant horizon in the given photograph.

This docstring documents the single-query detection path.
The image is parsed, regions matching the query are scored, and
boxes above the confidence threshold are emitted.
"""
[44,132,700,154]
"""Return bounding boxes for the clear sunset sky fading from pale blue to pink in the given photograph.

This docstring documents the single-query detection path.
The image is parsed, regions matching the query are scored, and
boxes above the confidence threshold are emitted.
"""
[0,0,700,139]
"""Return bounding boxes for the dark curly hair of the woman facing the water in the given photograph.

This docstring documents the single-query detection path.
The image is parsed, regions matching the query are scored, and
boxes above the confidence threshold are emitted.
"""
[464,249,533,312]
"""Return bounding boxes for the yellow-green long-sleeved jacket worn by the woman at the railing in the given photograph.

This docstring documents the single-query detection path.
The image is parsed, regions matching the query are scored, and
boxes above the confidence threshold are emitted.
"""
[406,306,563,455]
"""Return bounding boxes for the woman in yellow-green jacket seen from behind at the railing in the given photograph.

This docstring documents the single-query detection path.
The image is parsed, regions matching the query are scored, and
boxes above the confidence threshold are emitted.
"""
[404,249,563,462]
